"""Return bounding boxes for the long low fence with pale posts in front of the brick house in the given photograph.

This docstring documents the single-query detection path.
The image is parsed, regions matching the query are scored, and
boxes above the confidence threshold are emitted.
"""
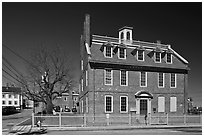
[32,113,202,127]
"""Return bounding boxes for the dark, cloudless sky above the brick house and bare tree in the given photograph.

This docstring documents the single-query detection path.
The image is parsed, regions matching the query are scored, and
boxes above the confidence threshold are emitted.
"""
[2,2,202,106]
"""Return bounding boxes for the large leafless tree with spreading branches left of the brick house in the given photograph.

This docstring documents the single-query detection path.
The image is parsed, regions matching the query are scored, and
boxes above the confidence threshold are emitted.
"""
[21,46,74,114]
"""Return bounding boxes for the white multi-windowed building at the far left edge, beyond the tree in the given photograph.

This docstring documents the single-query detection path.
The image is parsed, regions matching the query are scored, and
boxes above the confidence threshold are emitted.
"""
[2,86,23,109]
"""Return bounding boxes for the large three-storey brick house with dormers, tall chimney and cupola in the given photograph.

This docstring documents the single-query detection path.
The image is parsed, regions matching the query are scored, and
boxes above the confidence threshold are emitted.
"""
[79,15,189,115]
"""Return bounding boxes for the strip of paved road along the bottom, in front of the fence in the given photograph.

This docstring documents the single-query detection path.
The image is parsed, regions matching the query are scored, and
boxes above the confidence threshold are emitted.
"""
[43,128,202,135]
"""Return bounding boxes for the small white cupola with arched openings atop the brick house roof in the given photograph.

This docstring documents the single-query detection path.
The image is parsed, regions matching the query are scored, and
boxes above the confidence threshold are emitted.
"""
[119,26,133,44]
